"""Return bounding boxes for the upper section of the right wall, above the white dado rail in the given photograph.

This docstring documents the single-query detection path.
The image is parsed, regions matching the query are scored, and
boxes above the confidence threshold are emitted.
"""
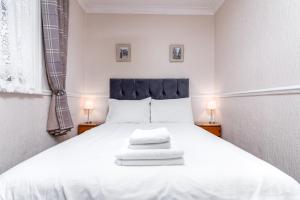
[215,0,300,92]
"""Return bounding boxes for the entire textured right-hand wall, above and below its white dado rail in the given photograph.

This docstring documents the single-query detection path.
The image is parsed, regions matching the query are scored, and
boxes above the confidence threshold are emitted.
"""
[215,0,300,181]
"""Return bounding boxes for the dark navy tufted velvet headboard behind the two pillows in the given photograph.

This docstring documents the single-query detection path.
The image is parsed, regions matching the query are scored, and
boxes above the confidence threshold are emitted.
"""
[110,78,189,100]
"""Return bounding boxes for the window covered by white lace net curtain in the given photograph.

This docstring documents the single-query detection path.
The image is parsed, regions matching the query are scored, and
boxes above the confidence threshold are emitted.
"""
[0,0,42,93]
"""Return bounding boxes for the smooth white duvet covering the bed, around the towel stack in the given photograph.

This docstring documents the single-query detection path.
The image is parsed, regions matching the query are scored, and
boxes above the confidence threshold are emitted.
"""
[0,124,300,200]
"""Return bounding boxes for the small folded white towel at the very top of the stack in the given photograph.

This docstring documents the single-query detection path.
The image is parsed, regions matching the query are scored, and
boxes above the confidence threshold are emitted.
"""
[129,128,170,144]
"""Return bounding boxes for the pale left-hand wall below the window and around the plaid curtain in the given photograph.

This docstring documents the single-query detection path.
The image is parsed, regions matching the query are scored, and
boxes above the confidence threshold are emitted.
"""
[0,0,84,174]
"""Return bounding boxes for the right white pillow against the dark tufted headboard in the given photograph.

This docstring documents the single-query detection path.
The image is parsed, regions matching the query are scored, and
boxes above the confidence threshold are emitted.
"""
[151,98,194,123]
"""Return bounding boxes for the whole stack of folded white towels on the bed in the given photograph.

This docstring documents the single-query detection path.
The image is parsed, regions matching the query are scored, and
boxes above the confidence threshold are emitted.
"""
[116,128,184,166]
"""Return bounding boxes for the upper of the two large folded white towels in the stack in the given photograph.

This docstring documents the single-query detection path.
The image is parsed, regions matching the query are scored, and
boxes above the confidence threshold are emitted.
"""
[116,148,183,160]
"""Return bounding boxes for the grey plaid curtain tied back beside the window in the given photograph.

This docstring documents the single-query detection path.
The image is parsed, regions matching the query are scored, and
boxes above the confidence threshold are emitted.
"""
[41,0,74,136]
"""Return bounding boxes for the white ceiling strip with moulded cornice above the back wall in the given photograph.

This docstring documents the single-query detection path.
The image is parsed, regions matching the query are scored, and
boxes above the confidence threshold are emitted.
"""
[77,0,224,15]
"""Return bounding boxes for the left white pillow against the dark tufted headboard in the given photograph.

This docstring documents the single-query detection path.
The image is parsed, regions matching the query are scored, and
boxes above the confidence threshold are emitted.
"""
[106,98,151,123]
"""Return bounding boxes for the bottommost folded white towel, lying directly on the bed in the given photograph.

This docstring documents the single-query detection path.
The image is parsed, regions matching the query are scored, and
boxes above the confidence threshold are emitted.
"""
[116,158,184,166]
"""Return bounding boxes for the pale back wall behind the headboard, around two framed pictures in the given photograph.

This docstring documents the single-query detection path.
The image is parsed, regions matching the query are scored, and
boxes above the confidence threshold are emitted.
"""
[84,14,214,120]
